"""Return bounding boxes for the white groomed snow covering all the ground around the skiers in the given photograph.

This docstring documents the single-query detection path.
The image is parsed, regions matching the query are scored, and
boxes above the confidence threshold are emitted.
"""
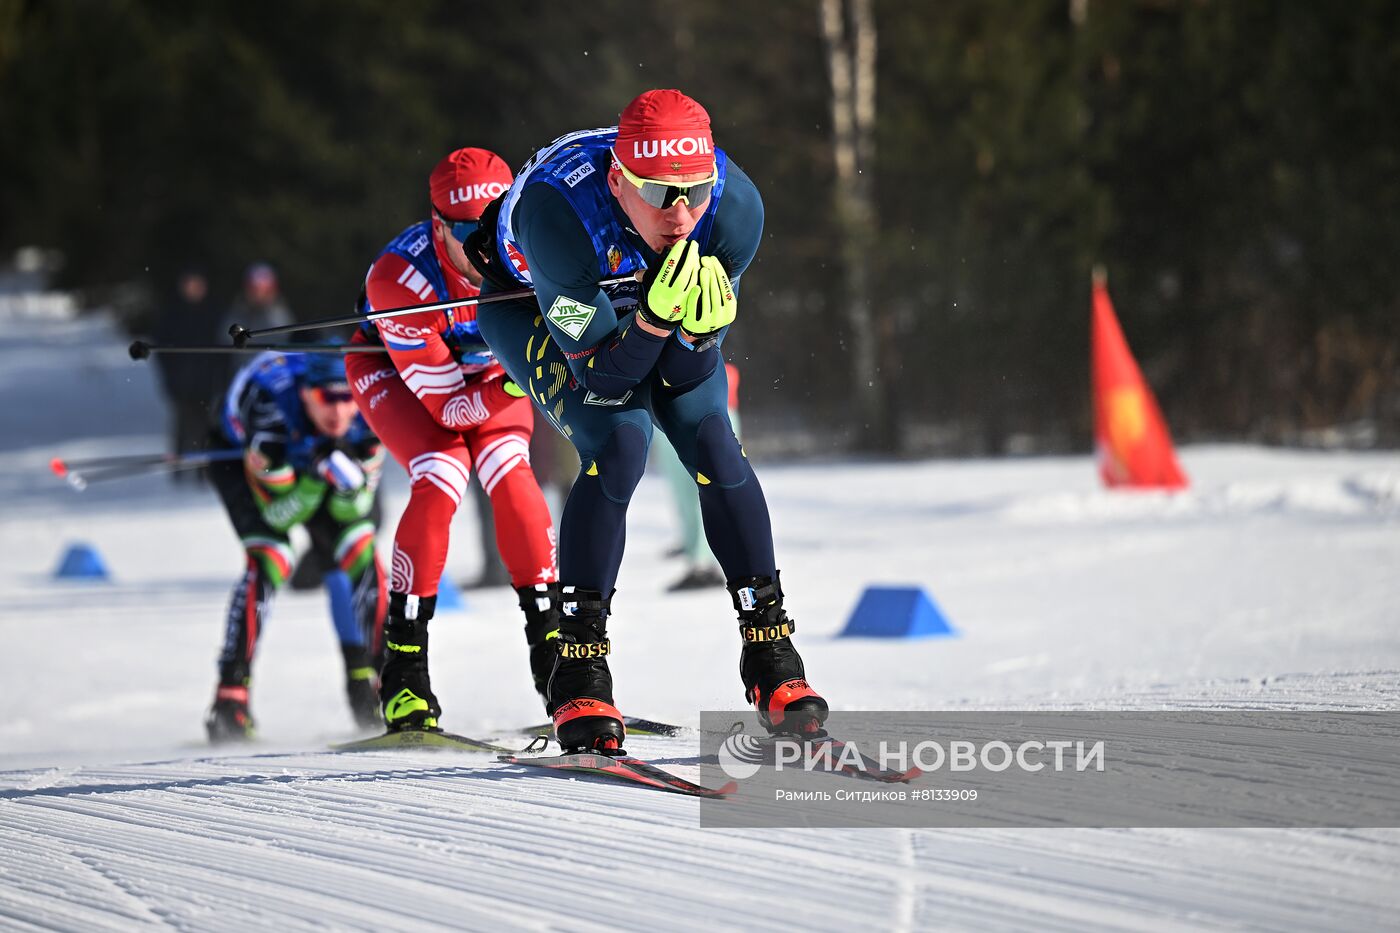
[0,313,1400,930]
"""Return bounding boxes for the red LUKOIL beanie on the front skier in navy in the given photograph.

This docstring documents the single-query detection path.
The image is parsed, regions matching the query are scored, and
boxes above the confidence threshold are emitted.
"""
[613,90,714,178]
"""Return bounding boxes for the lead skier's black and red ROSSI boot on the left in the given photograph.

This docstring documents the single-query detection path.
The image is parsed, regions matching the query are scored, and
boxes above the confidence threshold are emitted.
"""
[549,587,627,754]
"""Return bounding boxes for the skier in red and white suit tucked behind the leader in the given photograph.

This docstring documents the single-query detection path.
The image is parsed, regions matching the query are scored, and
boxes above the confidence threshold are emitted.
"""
[346,148,559,731]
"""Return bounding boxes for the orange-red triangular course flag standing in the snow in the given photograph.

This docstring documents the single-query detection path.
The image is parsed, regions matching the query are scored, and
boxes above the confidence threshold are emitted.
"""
[1092,272,1187,489]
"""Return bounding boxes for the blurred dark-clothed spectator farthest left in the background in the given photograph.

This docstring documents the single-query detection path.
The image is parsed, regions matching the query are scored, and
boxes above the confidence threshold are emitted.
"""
[154,268,223,483]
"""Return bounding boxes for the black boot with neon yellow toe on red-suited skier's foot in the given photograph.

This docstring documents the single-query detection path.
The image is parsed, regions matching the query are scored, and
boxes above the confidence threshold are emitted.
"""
[379,593,442,733]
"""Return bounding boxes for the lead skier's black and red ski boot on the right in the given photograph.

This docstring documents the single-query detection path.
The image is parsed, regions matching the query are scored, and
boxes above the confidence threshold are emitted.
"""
[728,577,829,735]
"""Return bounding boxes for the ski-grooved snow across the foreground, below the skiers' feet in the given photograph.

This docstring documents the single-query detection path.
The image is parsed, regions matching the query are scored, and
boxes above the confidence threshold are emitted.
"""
[0,741,1400,930]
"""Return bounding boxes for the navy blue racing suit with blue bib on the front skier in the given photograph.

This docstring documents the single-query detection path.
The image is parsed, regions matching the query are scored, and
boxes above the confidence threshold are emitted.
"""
[477,129,777,594]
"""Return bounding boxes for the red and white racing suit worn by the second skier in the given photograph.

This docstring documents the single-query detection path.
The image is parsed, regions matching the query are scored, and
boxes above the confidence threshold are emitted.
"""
[346,237,557,597]
